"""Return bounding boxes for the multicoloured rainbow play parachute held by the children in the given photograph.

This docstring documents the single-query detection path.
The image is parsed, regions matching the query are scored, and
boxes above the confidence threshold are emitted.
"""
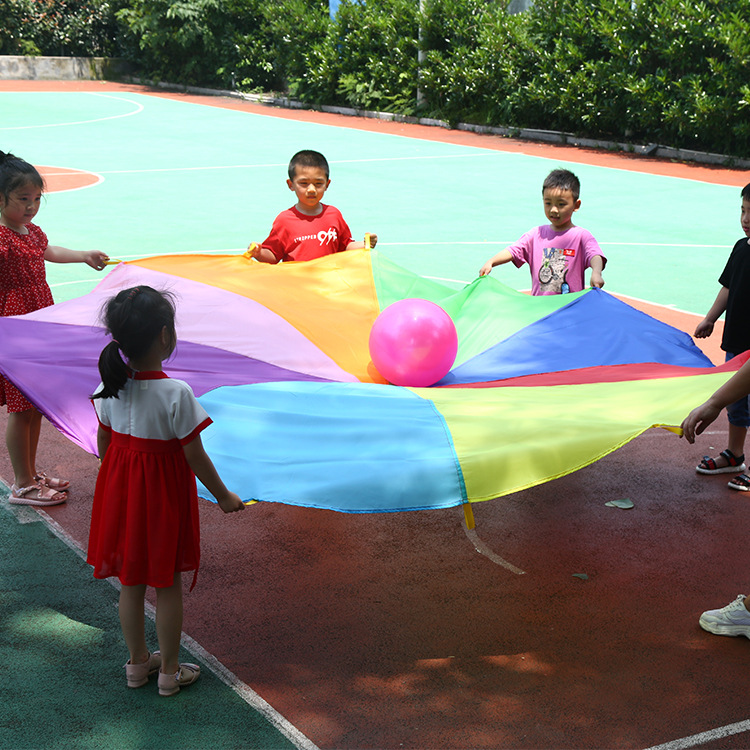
[0,250,738,513]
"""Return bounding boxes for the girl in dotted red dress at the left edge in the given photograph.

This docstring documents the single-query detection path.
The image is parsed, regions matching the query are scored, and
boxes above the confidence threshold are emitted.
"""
[0,151,109,505]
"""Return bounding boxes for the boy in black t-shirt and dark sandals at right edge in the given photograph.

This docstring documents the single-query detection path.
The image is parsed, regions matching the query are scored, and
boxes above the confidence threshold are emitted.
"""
[694,184,750,492]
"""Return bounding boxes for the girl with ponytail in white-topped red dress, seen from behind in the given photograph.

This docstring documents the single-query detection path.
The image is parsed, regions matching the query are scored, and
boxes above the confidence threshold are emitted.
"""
[88,286,245,695]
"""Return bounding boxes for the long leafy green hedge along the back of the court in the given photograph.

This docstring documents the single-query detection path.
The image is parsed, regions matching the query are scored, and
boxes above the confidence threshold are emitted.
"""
[5,0,750,157]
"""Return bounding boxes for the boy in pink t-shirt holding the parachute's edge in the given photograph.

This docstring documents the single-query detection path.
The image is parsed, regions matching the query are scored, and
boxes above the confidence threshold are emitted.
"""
[479,169,607,294]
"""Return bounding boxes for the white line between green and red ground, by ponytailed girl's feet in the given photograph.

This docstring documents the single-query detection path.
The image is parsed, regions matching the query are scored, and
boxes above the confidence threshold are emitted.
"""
[3,494,319,750]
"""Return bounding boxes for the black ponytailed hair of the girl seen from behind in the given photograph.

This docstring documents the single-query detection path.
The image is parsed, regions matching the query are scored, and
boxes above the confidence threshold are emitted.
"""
[91,285,176,398]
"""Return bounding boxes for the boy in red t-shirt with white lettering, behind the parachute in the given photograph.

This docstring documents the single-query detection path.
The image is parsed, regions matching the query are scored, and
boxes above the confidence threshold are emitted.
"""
[248,150,378,263]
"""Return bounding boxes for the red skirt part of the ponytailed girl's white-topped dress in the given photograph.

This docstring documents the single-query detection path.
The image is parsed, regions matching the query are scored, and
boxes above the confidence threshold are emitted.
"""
[87,431,200,588]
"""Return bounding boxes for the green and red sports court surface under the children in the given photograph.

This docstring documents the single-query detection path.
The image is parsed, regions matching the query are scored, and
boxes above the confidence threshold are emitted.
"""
[0,81,750,750]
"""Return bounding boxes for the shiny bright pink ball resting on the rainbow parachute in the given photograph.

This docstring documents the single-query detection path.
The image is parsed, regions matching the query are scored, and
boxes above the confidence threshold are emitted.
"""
[370,299,458,388]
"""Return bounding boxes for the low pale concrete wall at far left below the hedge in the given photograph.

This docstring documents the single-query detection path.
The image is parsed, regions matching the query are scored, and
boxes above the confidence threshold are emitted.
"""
[0,55,129,81]
